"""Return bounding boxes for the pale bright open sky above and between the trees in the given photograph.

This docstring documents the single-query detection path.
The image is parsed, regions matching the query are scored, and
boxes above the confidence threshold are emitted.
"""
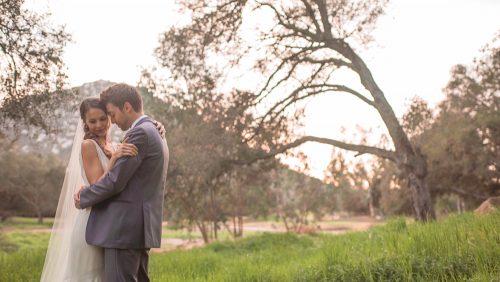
[26,0,500,178]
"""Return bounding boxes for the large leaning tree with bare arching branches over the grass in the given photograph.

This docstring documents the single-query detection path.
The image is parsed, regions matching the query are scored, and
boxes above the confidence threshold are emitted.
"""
[151,0,435,220]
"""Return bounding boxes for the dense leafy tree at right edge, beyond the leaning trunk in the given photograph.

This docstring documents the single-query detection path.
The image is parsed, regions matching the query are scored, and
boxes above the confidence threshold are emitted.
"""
[419,33,500,208]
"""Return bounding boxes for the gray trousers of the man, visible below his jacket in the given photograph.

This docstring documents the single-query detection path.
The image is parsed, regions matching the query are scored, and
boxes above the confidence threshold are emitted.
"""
[104,249,149,282]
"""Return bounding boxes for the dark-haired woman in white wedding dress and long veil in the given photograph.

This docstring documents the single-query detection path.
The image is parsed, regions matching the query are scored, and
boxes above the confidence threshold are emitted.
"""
[41,98,158,282]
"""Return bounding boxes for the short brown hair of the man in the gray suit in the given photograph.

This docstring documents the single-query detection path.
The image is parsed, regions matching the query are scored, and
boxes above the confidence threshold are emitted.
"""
[100,83,142,112]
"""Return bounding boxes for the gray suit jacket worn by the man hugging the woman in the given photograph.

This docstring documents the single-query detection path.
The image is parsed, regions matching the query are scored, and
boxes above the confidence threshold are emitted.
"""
[80,117,169,249]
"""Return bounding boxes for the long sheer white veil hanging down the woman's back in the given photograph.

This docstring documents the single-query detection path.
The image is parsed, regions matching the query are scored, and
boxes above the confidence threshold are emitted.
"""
[40,119,84,282]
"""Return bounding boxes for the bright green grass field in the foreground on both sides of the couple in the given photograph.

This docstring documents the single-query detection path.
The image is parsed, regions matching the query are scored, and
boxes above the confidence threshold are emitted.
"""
[0,212,500,281]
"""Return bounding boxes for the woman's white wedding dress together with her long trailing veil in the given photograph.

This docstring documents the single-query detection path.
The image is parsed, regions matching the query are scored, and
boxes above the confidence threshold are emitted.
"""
[40,122,109,282]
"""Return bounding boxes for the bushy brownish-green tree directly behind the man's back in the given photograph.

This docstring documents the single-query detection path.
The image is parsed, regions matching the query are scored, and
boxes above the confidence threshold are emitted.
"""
[141,88,258,241]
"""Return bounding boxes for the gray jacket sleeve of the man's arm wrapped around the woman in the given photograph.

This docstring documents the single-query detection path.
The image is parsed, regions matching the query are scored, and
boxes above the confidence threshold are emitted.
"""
[80,128,148,209]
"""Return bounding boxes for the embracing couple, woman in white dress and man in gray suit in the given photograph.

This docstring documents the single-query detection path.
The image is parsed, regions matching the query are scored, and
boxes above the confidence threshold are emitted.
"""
[41,84,169,282]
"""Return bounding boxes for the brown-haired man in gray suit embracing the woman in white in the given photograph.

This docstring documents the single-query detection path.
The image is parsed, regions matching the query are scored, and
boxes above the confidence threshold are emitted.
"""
[75,84,169,282]
